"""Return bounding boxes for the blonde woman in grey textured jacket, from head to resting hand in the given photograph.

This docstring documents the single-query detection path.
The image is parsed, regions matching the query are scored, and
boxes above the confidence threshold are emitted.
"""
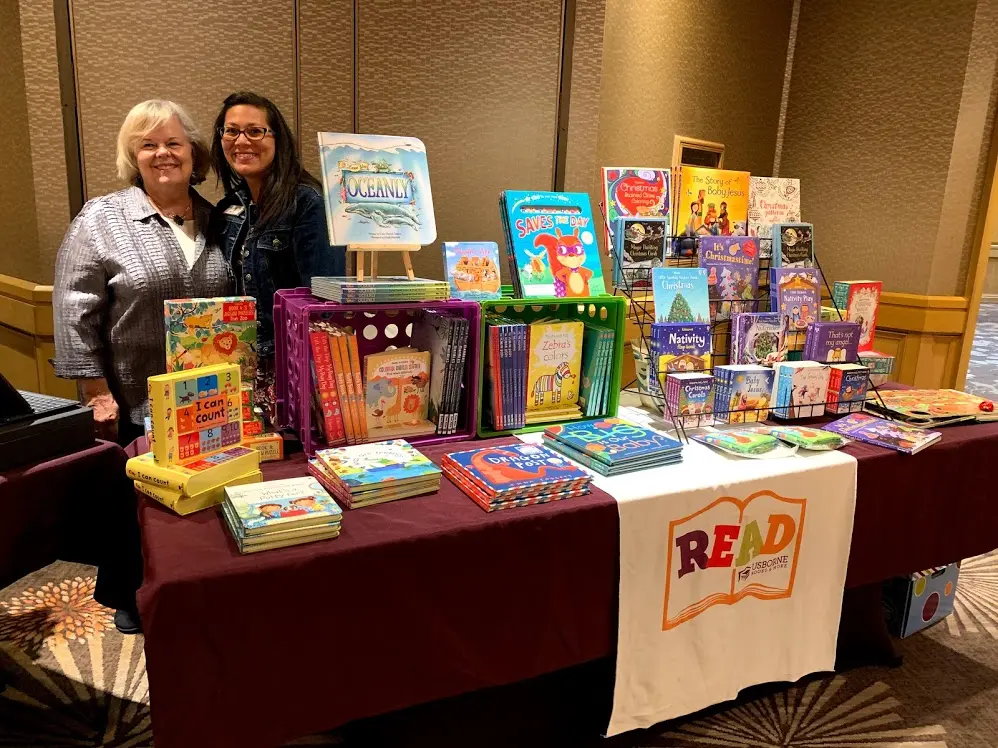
[52,100,232,445]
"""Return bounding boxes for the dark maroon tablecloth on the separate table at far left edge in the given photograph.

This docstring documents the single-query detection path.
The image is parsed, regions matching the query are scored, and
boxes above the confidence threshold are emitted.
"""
[0,442,127,588]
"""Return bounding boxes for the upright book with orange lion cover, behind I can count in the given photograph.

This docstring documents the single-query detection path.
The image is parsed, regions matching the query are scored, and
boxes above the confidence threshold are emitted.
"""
[163,296,256,382]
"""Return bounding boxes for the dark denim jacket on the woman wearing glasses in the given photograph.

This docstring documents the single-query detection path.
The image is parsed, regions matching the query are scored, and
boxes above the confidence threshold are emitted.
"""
[212,184,346,357]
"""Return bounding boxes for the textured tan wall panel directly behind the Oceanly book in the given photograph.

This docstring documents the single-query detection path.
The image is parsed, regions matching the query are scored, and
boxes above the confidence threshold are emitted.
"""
[356,0,561,277]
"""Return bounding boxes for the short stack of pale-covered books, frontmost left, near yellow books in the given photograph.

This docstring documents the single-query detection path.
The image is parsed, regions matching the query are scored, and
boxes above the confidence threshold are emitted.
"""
[222,478,343,553]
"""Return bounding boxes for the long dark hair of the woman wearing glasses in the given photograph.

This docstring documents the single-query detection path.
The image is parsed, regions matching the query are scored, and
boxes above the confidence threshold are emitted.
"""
[211,91,322,226]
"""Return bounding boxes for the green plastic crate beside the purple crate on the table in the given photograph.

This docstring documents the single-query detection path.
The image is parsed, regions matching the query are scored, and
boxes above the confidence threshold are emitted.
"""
[478,295,627,438]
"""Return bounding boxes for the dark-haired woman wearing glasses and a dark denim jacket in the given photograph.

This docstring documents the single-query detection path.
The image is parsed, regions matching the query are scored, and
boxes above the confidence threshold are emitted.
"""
[211,92,346,424]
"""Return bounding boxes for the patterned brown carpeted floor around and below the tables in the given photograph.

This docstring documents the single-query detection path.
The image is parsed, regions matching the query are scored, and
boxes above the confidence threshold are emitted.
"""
[0,551,998,748]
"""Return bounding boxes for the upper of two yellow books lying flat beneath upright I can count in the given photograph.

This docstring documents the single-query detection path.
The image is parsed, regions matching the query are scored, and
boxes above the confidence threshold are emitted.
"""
[125,445,260,496]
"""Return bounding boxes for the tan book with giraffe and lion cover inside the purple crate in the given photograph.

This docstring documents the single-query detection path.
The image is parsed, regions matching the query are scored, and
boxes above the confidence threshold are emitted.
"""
[364,348,436,441]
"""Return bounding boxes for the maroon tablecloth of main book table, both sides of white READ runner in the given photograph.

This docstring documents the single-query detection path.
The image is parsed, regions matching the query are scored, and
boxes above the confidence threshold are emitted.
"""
[139,424,998,748]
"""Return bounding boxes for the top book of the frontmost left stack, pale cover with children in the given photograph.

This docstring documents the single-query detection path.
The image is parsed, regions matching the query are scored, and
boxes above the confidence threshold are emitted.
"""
[225,478,343,535]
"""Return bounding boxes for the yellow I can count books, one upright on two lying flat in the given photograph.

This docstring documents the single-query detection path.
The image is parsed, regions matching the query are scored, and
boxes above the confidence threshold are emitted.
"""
[126,364,263,515]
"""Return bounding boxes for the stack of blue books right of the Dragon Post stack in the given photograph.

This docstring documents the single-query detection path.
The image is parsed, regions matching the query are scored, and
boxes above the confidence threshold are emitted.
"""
[544,418,683,476]
